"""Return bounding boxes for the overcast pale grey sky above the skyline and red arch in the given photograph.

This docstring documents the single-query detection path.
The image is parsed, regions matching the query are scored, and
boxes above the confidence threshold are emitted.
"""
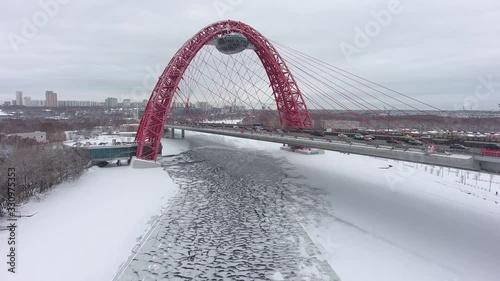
[0,0,500,110]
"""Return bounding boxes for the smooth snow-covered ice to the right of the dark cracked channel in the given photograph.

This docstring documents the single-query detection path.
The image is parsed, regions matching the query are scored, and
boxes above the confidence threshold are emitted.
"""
[182,133,500,281]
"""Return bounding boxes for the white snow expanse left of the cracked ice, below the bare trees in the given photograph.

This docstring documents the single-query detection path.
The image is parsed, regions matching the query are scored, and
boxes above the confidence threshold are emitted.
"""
[0,163,177,281]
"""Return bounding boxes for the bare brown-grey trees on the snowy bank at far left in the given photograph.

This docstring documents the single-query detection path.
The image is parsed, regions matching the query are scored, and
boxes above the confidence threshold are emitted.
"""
[0,140,89,216]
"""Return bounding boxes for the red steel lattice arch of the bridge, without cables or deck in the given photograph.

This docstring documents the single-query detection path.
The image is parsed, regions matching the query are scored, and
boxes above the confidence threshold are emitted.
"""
[136,20,312,161]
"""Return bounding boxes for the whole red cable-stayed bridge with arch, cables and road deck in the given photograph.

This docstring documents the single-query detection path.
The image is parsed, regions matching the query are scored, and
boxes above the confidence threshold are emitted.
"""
[136,21,500,172]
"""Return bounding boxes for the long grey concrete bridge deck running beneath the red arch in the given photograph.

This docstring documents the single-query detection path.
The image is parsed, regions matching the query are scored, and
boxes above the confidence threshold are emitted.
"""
[166,125,480,171]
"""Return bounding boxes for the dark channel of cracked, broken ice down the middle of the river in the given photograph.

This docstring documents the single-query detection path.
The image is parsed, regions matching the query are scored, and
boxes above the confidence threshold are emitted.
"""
[114,138,340,281]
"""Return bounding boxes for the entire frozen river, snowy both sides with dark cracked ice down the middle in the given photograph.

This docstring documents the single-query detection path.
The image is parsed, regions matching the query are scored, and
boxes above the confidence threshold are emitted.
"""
[4,133,500,281]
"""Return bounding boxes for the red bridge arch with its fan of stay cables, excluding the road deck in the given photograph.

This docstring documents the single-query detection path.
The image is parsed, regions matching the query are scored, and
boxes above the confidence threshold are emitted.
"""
[136,21,492,160]
